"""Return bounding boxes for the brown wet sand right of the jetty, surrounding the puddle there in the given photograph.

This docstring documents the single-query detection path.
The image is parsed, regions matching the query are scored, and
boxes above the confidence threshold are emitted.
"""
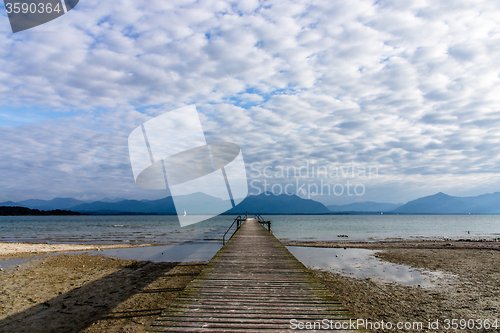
[313,245,500,332]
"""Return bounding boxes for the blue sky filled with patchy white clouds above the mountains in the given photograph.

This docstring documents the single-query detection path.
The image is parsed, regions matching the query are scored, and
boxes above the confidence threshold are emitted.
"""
[0,0,500,204]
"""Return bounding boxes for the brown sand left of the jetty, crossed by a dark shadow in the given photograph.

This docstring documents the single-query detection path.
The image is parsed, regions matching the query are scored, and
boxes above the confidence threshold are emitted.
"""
[0,250,205,332]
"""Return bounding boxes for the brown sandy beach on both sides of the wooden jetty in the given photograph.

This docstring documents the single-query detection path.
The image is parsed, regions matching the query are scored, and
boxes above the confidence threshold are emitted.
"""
[0,241,500,332]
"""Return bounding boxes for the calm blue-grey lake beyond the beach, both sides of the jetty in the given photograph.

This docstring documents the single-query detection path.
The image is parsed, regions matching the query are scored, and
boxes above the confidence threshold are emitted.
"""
[0,215,500,244]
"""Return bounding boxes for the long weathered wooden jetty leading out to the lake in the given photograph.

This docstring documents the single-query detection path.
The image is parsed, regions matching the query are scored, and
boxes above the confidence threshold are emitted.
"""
[149,219,355,333]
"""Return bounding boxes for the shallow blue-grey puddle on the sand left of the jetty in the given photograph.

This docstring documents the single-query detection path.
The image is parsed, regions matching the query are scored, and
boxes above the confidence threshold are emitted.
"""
[0,243,222,270]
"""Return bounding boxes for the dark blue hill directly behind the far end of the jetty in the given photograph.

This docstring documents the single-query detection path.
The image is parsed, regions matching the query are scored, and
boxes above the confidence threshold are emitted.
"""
[226,192,330,214]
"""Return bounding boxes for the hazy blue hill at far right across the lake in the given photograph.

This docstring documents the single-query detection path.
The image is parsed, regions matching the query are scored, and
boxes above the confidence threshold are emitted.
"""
[392,192,500,214]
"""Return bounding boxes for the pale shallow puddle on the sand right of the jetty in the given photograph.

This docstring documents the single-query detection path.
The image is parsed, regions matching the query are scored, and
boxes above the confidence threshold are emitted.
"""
[287,246,453,287]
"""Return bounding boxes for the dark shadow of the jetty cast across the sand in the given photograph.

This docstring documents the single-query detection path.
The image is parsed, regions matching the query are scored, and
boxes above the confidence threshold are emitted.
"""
[0,262,204,333]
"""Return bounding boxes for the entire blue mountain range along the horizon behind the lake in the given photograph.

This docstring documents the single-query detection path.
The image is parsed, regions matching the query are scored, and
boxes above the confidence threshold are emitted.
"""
[0,192,500,215]
